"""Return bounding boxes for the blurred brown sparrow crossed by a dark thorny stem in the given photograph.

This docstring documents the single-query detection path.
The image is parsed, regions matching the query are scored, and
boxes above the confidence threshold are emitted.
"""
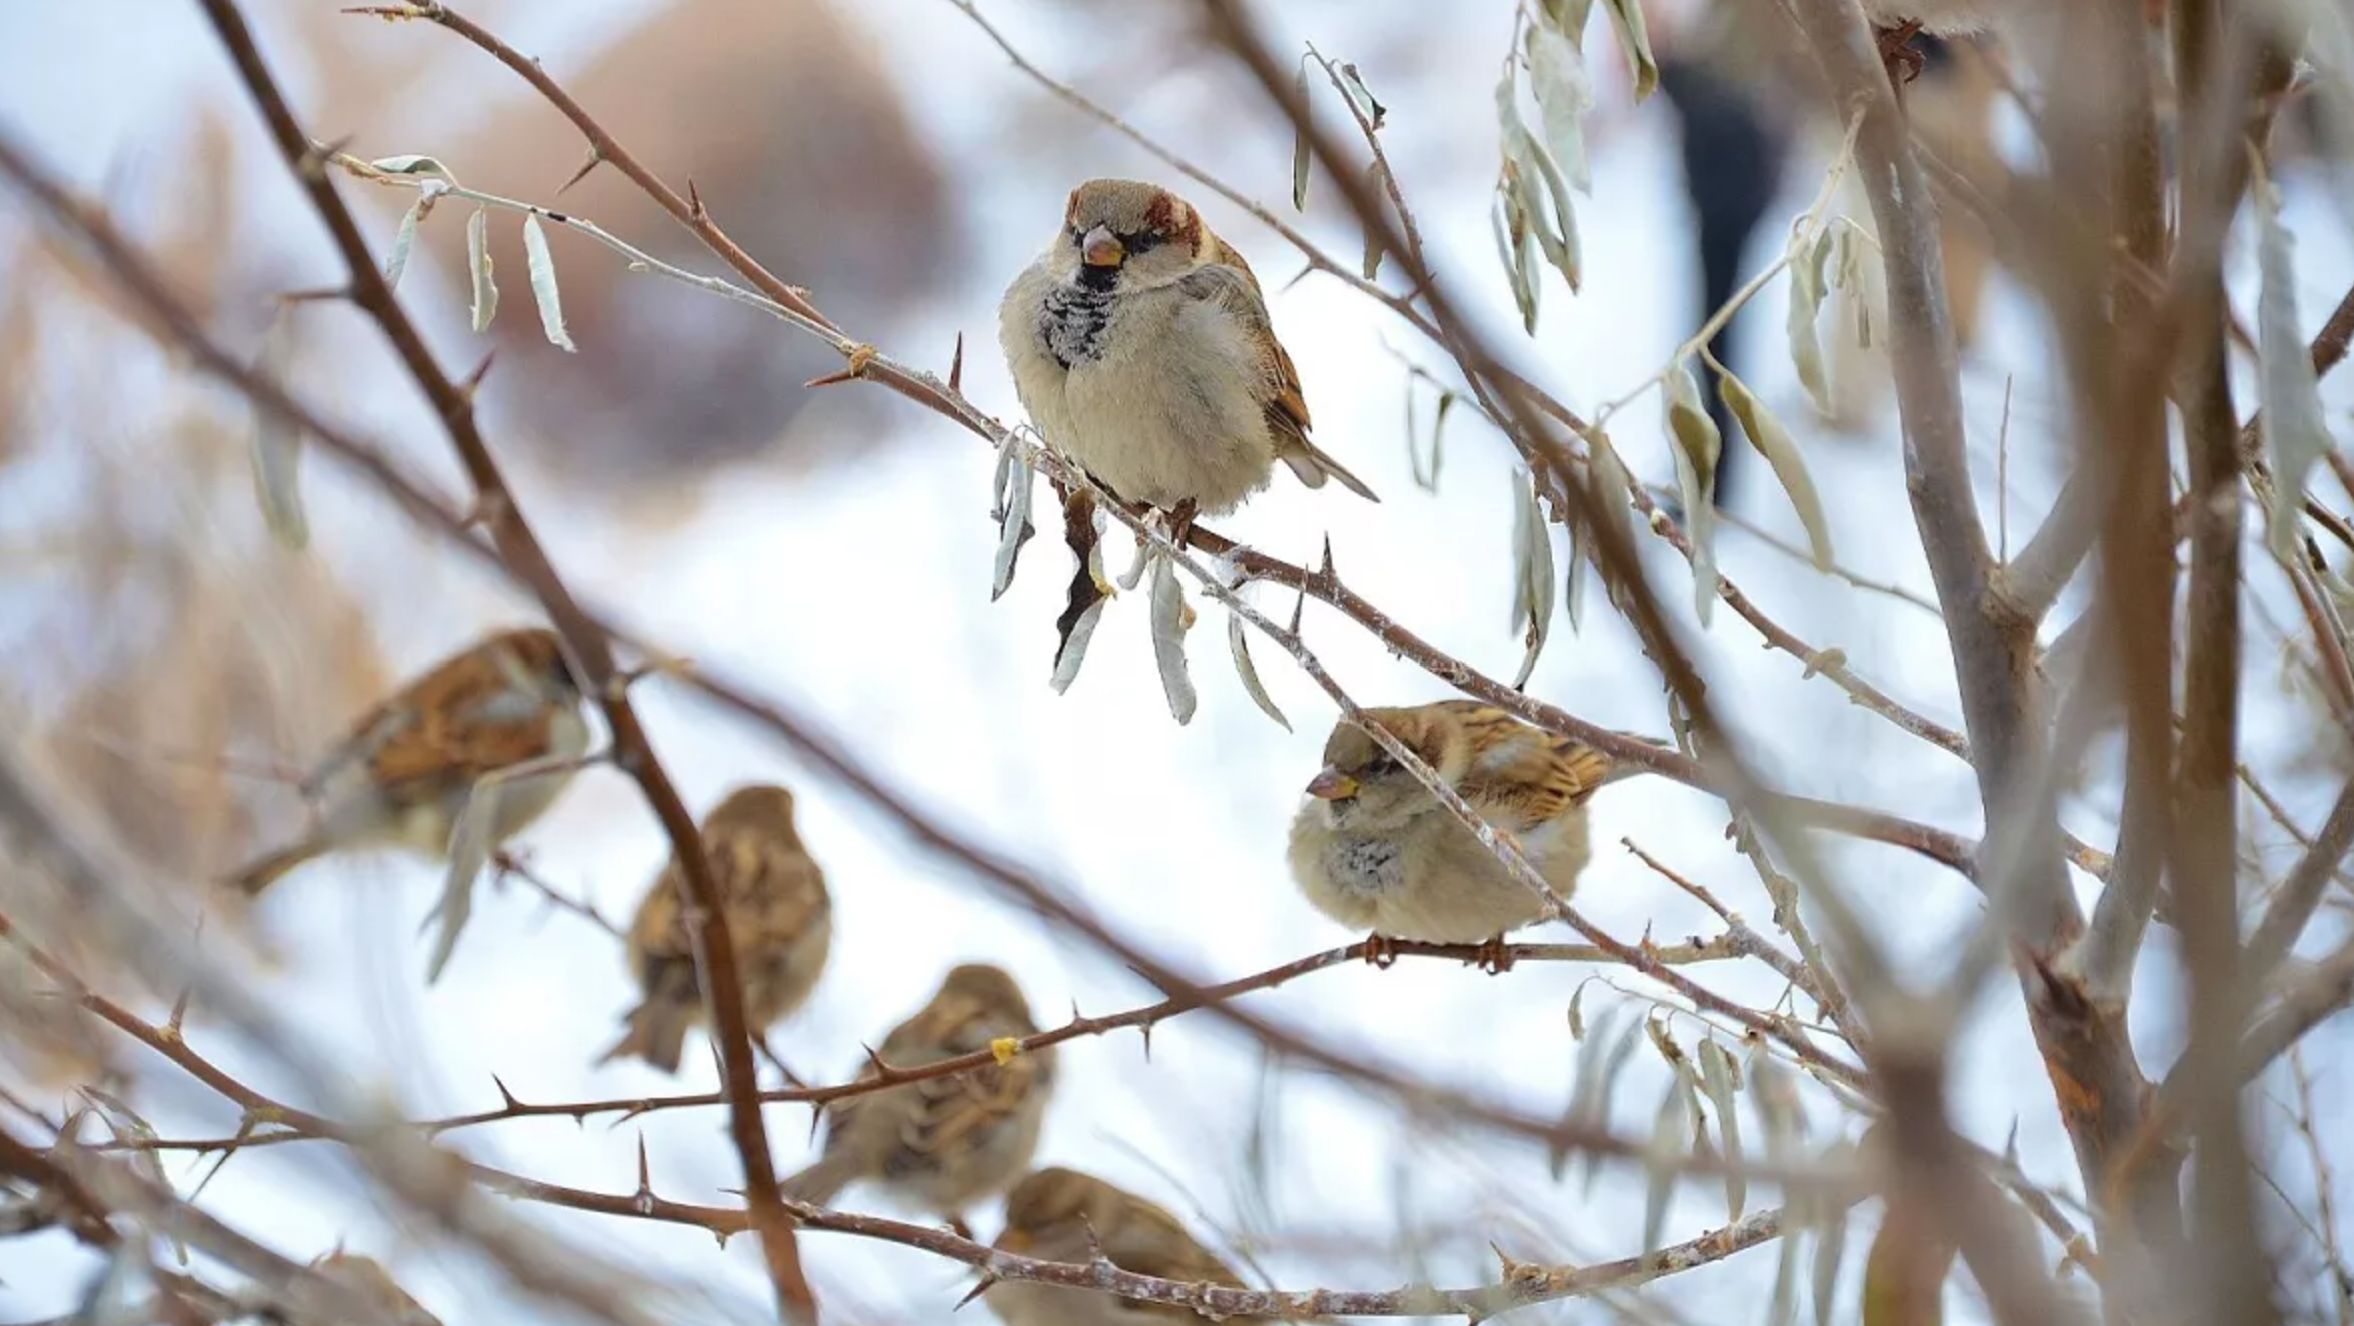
[598,787,833,1072]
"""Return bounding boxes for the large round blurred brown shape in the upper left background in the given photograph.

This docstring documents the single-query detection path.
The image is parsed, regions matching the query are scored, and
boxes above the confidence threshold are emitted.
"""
[390,0,958,488]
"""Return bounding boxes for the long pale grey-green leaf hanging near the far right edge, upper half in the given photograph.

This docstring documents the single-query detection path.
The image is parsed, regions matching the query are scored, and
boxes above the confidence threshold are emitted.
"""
[2255,177,2330,558]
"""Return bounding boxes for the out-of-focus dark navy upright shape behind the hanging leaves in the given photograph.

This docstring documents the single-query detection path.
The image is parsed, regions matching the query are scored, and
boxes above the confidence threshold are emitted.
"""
[1660,42,1791,506]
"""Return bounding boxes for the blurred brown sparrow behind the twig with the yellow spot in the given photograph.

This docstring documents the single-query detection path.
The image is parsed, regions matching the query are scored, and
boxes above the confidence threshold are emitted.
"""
[784,963,1055,1215]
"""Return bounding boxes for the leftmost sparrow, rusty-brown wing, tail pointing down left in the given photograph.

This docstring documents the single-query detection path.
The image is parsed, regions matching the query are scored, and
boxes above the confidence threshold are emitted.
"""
[231,626,589,893]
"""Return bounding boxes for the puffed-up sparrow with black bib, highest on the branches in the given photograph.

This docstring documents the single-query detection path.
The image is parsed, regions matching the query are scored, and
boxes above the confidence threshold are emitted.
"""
[998,179,1379,525]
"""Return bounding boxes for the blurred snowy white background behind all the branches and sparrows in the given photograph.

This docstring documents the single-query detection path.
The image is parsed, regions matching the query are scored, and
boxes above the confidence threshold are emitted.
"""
[0,0,2354,1326]
